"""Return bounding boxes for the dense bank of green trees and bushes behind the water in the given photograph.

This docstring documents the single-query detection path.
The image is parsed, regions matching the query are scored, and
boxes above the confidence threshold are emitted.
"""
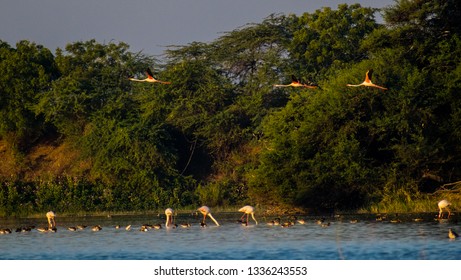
[0,0,461,215]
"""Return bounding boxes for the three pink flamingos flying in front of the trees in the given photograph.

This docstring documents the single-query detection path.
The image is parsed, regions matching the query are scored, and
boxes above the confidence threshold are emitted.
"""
[129,68,387,90]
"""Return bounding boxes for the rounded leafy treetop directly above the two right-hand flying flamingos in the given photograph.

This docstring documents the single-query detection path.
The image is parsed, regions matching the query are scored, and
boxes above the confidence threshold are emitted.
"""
[289,4,379,79]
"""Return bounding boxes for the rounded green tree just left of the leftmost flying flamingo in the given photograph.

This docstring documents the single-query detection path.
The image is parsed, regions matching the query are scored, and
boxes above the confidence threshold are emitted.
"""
[36,40,147,137]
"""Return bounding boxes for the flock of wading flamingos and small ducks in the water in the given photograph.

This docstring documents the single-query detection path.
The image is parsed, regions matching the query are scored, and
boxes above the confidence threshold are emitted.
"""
[0,199,459,239]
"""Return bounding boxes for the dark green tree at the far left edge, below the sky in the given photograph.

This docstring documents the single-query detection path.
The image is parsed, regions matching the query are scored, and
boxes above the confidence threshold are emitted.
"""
[0,41,58,151]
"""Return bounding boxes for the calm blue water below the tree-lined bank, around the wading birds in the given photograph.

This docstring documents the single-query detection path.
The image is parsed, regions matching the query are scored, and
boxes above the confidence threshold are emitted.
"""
[0,213,461,260]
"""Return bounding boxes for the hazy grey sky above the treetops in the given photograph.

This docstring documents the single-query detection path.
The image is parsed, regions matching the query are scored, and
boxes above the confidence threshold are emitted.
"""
[0,0,395,55]
